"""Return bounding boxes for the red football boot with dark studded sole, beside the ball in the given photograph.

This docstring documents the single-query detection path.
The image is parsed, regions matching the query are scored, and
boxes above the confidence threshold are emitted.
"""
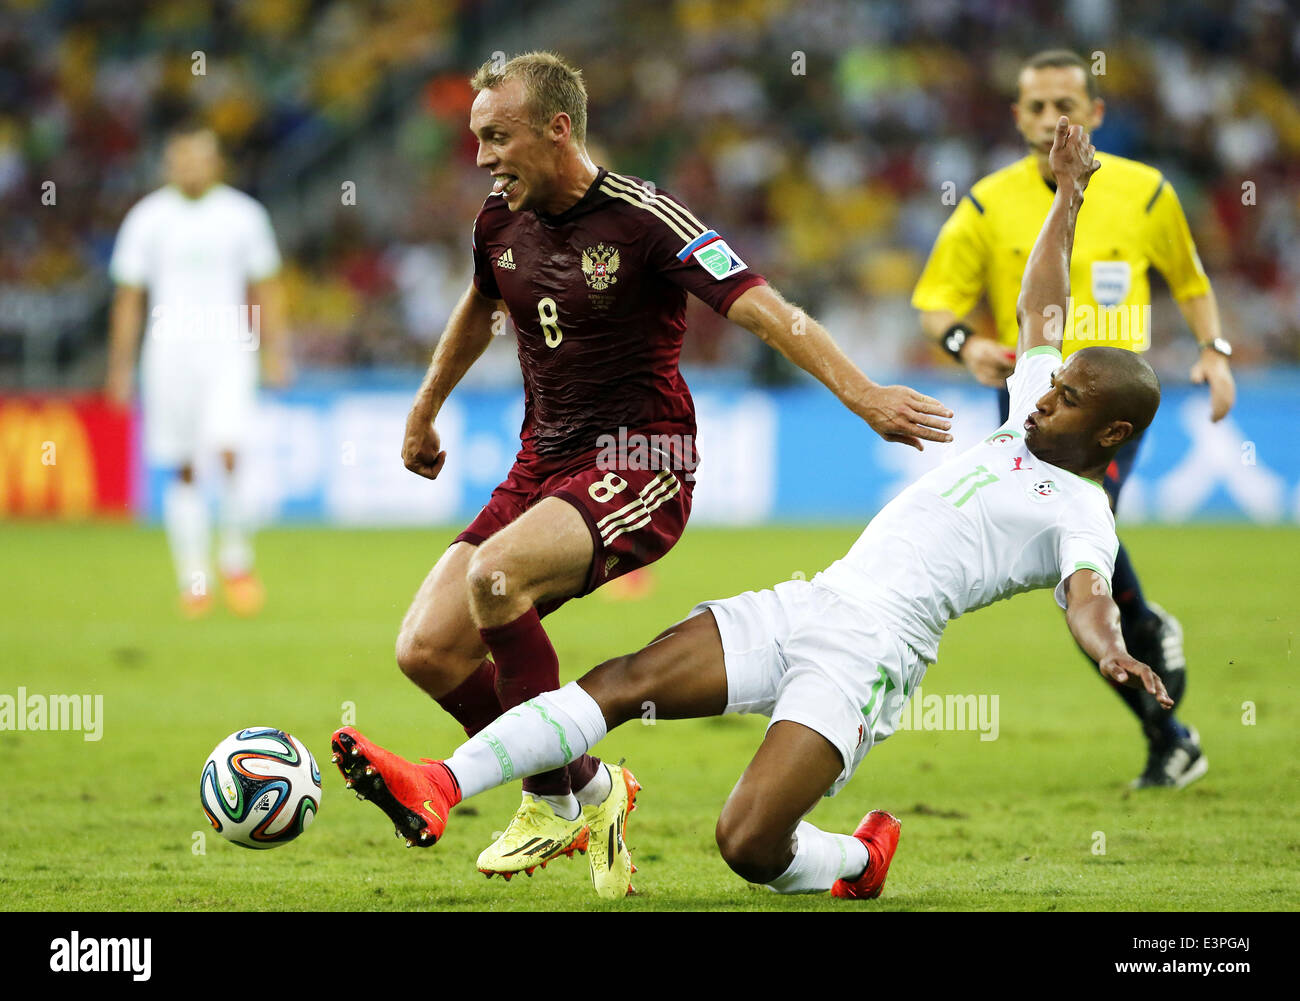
[330,727,460,848]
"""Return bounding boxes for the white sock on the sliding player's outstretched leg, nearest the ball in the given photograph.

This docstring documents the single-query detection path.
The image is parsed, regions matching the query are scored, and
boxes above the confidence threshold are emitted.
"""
[446,681,605,800]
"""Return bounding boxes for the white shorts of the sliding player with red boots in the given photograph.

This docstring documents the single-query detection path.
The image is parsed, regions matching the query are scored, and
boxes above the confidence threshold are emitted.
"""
[692,580,926,796]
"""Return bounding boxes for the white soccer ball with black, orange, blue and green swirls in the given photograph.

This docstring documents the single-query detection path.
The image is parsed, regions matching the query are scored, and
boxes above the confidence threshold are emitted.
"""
[199,727,321,848]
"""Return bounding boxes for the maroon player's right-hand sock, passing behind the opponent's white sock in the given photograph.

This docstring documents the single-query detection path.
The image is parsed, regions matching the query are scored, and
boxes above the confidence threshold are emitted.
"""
[478,608,599,796]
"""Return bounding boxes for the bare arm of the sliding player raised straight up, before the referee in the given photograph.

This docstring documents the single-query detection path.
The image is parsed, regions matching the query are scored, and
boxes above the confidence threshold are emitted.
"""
[1015,116,1101,355]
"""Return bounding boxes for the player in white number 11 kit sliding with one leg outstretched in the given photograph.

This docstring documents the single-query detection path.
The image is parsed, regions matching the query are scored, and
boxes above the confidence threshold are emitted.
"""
[333,118,1173,898]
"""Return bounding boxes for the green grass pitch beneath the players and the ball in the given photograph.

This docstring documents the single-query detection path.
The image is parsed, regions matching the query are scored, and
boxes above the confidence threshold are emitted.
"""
[0,523,1300,911]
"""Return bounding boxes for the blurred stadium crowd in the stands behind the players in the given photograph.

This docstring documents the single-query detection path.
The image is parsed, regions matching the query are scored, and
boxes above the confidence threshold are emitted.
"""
[0,0,1300,387]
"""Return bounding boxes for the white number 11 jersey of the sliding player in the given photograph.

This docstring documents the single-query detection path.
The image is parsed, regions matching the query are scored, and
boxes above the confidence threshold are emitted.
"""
[814,347,1119,663]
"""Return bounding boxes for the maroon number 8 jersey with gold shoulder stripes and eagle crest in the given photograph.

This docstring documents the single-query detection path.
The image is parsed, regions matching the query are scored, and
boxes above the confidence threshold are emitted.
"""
[473,168,764,456]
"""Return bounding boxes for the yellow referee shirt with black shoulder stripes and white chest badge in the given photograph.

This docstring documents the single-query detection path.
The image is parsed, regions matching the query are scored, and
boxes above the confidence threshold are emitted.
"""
[911,152,1210,356]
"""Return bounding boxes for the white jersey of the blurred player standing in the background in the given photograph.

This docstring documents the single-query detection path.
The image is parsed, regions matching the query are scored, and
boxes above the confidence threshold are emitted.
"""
[109,185,280,350]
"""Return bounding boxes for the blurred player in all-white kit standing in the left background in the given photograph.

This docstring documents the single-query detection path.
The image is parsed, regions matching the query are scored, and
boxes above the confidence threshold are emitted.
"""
[105,127,289,618]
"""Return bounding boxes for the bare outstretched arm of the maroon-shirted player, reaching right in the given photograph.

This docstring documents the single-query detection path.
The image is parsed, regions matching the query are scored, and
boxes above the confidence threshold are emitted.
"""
[727,285,953,450]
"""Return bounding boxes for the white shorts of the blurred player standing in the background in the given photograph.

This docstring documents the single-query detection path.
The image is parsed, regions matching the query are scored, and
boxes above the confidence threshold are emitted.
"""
[140,339,257,467]
